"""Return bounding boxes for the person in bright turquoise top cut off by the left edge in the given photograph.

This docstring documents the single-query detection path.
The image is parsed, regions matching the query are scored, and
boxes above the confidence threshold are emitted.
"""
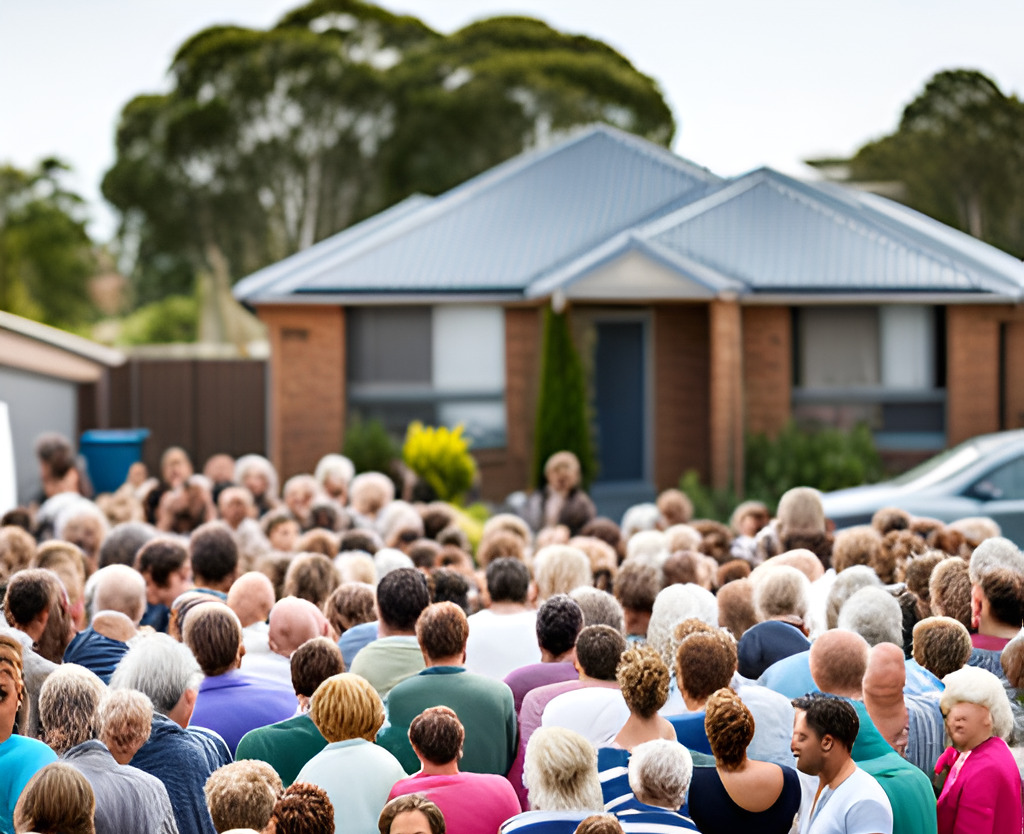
[0,634,56,831]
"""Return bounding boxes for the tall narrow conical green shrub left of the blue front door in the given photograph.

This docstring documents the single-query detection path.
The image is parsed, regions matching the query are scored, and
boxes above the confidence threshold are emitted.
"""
[534,306,597,489]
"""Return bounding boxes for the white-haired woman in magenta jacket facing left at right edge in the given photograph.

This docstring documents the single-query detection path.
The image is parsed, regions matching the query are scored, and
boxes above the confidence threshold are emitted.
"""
[935,666,1024,834]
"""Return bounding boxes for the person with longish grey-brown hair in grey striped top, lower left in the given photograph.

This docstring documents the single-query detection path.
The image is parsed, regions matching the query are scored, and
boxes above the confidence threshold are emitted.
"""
[39,663,177,834]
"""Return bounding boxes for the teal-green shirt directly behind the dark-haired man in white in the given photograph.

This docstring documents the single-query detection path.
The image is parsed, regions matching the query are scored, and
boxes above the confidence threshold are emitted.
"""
[851,701,938,834]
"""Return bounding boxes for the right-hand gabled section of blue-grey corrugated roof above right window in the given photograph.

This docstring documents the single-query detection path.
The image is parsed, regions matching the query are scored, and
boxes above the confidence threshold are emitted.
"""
[638,169,1024,296]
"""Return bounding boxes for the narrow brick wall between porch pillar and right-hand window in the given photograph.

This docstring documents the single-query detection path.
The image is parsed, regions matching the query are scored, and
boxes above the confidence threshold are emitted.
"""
[743,306,793,434]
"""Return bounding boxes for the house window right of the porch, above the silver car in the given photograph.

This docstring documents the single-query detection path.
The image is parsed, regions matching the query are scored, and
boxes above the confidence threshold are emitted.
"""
[793,305,945,450]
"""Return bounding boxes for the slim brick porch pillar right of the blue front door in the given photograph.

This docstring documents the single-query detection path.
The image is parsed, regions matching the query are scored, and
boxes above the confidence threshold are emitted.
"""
[710,298,743,492]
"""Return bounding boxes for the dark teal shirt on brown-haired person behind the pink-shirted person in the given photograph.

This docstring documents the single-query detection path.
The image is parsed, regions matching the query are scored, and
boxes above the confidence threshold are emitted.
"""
[377,666,517,776]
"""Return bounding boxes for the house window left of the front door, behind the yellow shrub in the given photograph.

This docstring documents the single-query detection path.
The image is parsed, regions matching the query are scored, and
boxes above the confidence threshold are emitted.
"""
[346,304,505,449]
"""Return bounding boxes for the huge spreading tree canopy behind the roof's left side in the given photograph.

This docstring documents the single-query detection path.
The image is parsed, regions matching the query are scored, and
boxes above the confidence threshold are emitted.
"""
[102,0,674,301]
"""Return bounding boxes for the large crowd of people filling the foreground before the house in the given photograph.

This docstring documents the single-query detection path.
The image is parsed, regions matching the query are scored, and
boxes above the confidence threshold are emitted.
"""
[0,435,1024,834]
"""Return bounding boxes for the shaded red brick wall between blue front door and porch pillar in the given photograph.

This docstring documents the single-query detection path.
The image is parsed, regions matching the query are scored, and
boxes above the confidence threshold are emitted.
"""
[653,304,711,490]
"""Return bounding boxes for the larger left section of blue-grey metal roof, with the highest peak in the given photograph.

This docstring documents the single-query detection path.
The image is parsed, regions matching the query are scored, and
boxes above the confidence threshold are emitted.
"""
[234,125,722,303]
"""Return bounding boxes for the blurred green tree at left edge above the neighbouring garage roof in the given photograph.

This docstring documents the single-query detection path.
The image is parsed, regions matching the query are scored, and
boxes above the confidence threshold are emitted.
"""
[0,159,96,327]
